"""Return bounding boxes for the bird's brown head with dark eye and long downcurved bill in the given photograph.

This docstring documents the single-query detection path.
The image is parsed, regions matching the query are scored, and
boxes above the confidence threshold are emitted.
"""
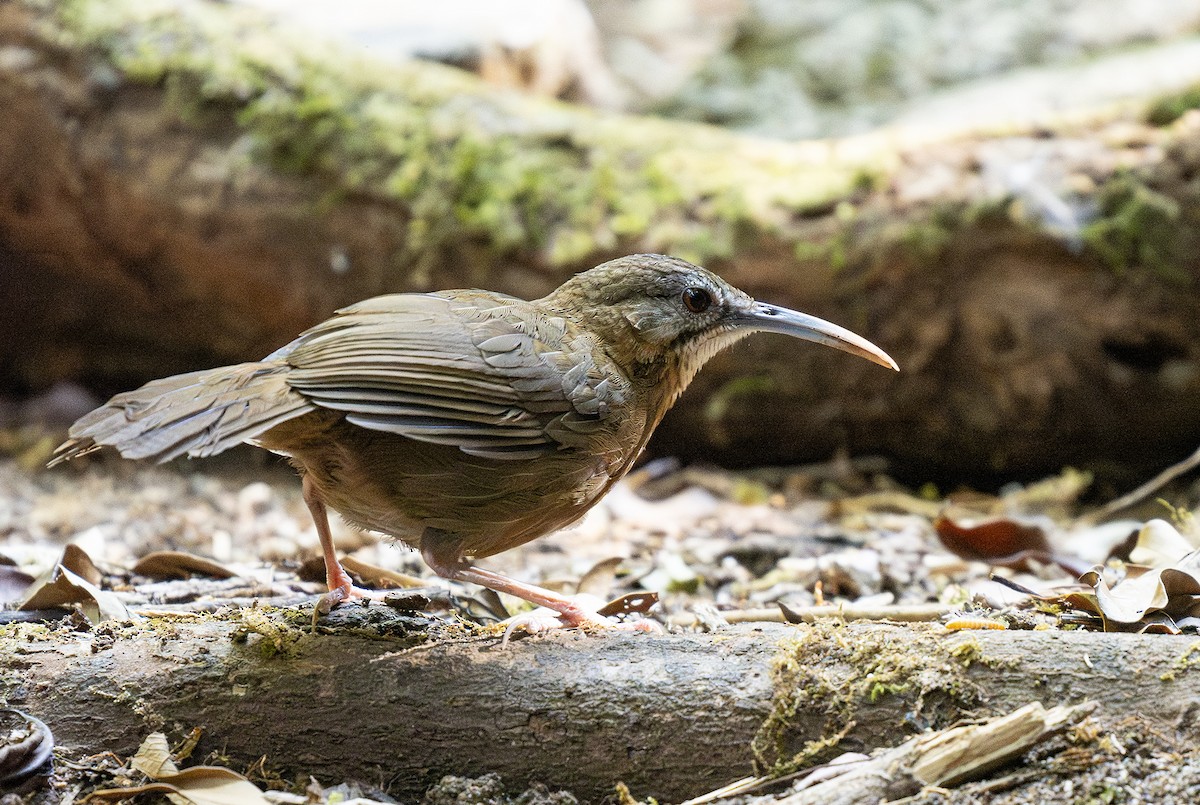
[544,254,896,390]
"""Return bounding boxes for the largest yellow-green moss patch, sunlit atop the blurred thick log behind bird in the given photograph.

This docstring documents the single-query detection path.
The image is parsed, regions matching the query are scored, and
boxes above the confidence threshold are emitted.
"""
[49,0,878,271]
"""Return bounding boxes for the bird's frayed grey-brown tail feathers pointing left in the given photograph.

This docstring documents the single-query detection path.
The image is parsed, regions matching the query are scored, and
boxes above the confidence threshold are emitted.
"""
[50,361,314,467]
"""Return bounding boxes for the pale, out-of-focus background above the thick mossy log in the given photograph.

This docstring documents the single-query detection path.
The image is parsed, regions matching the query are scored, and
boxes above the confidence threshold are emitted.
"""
[238,0,1200,139]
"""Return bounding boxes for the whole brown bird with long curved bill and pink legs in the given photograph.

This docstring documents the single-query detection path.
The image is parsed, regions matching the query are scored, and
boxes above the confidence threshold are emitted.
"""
[50,254,896,625]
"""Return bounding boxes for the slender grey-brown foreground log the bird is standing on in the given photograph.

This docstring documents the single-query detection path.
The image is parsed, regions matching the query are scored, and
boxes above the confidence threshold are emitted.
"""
[7,606,1200,801]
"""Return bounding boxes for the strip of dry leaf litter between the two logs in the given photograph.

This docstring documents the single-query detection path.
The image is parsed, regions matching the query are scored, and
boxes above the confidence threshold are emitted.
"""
[0,453,1200,801]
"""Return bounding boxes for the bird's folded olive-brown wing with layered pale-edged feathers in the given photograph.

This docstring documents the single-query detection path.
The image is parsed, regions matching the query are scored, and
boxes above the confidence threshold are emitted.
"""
[279,292,628,459]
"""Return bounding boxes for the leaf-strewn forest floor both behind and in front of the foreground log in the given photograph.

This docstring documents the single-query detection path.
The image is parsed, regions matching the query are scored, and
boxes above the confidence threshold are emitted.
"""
[0,451,1200,805]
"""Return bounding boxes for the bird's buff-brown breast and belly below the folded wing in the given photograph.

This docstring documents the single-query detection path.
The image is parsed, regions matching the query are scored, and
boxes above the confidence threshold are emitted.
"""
[263,411,644,558]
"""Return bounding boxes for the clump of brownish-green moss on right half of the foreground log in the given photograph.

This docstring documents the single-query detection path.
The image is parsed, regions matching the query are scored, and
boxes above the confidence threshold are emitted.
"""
[751,621,988,775]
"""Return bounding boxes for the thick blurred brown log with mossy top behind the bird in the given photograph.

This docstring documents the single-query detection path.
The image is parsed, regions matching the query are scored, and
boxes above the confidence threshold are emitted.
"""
[7,0,1200,481]
